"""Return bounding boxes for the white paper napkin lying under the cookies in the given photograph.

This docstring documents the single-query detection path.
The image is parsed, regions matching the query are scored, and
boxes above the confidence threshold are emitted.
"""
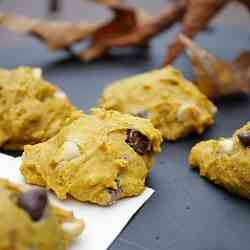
[0,153,154,250]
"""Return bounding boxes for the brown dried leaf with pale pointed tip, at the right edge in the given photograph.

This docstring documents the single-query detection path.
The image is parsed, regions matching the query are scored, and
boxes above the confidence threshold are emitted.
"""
[179,35,250,99]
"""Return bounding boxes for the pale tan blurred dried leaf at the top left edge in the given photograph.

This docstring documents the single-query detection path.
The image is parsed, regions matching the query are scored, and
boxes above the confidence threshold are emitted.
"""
[0,14,97,50]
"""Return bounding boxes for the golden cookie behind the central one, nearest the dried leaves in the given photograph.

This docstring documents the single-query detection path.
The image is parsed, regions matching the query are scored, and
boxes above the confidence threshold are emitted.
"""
[100,66,217,140]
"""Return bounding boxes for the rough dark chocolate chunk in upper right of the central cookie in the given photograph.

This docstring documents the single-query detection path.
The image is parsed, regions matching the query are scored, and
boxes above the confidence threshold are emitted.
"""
[126,129,151,155]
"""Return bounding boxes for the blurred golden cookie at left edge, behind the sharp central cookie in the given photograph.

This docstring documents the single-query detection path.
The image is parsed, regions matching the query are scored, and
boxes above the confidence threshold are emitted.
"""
[0,67,75,150]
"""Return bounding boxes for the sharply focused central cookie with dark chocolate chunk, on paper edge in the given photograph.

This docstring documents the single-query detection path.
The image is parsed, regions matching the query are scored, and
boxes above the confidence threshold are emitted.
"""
[21,109,162,206]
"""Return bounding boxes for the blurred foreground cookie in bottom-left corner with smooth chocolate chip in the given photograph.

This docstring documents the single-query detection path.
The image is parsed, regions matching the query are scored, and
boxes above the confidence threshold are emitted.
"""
[0,179,84,250]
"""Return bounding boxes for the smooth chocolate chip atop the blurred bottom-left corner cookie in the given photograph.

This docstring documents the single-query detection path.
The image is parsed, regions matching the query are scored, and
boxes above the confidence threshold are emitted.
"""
[17,188,48,221]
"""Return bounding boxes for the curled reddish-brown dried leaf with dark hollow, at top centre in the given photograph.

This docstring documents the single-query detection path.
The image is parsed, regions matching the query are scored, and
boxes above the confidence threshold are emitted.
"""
[81,0,186,60]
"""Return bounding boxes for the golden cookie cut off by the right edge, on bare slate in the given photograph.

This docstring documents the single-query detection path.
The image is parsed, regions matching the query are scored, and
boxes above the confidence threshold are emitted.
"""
[189,123,250,199]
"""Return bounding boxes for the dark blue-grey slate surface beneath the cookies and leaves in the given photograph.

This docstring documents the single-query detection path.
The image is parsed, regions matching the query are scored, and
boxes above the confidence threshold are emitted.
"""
[0,27,250,250]
